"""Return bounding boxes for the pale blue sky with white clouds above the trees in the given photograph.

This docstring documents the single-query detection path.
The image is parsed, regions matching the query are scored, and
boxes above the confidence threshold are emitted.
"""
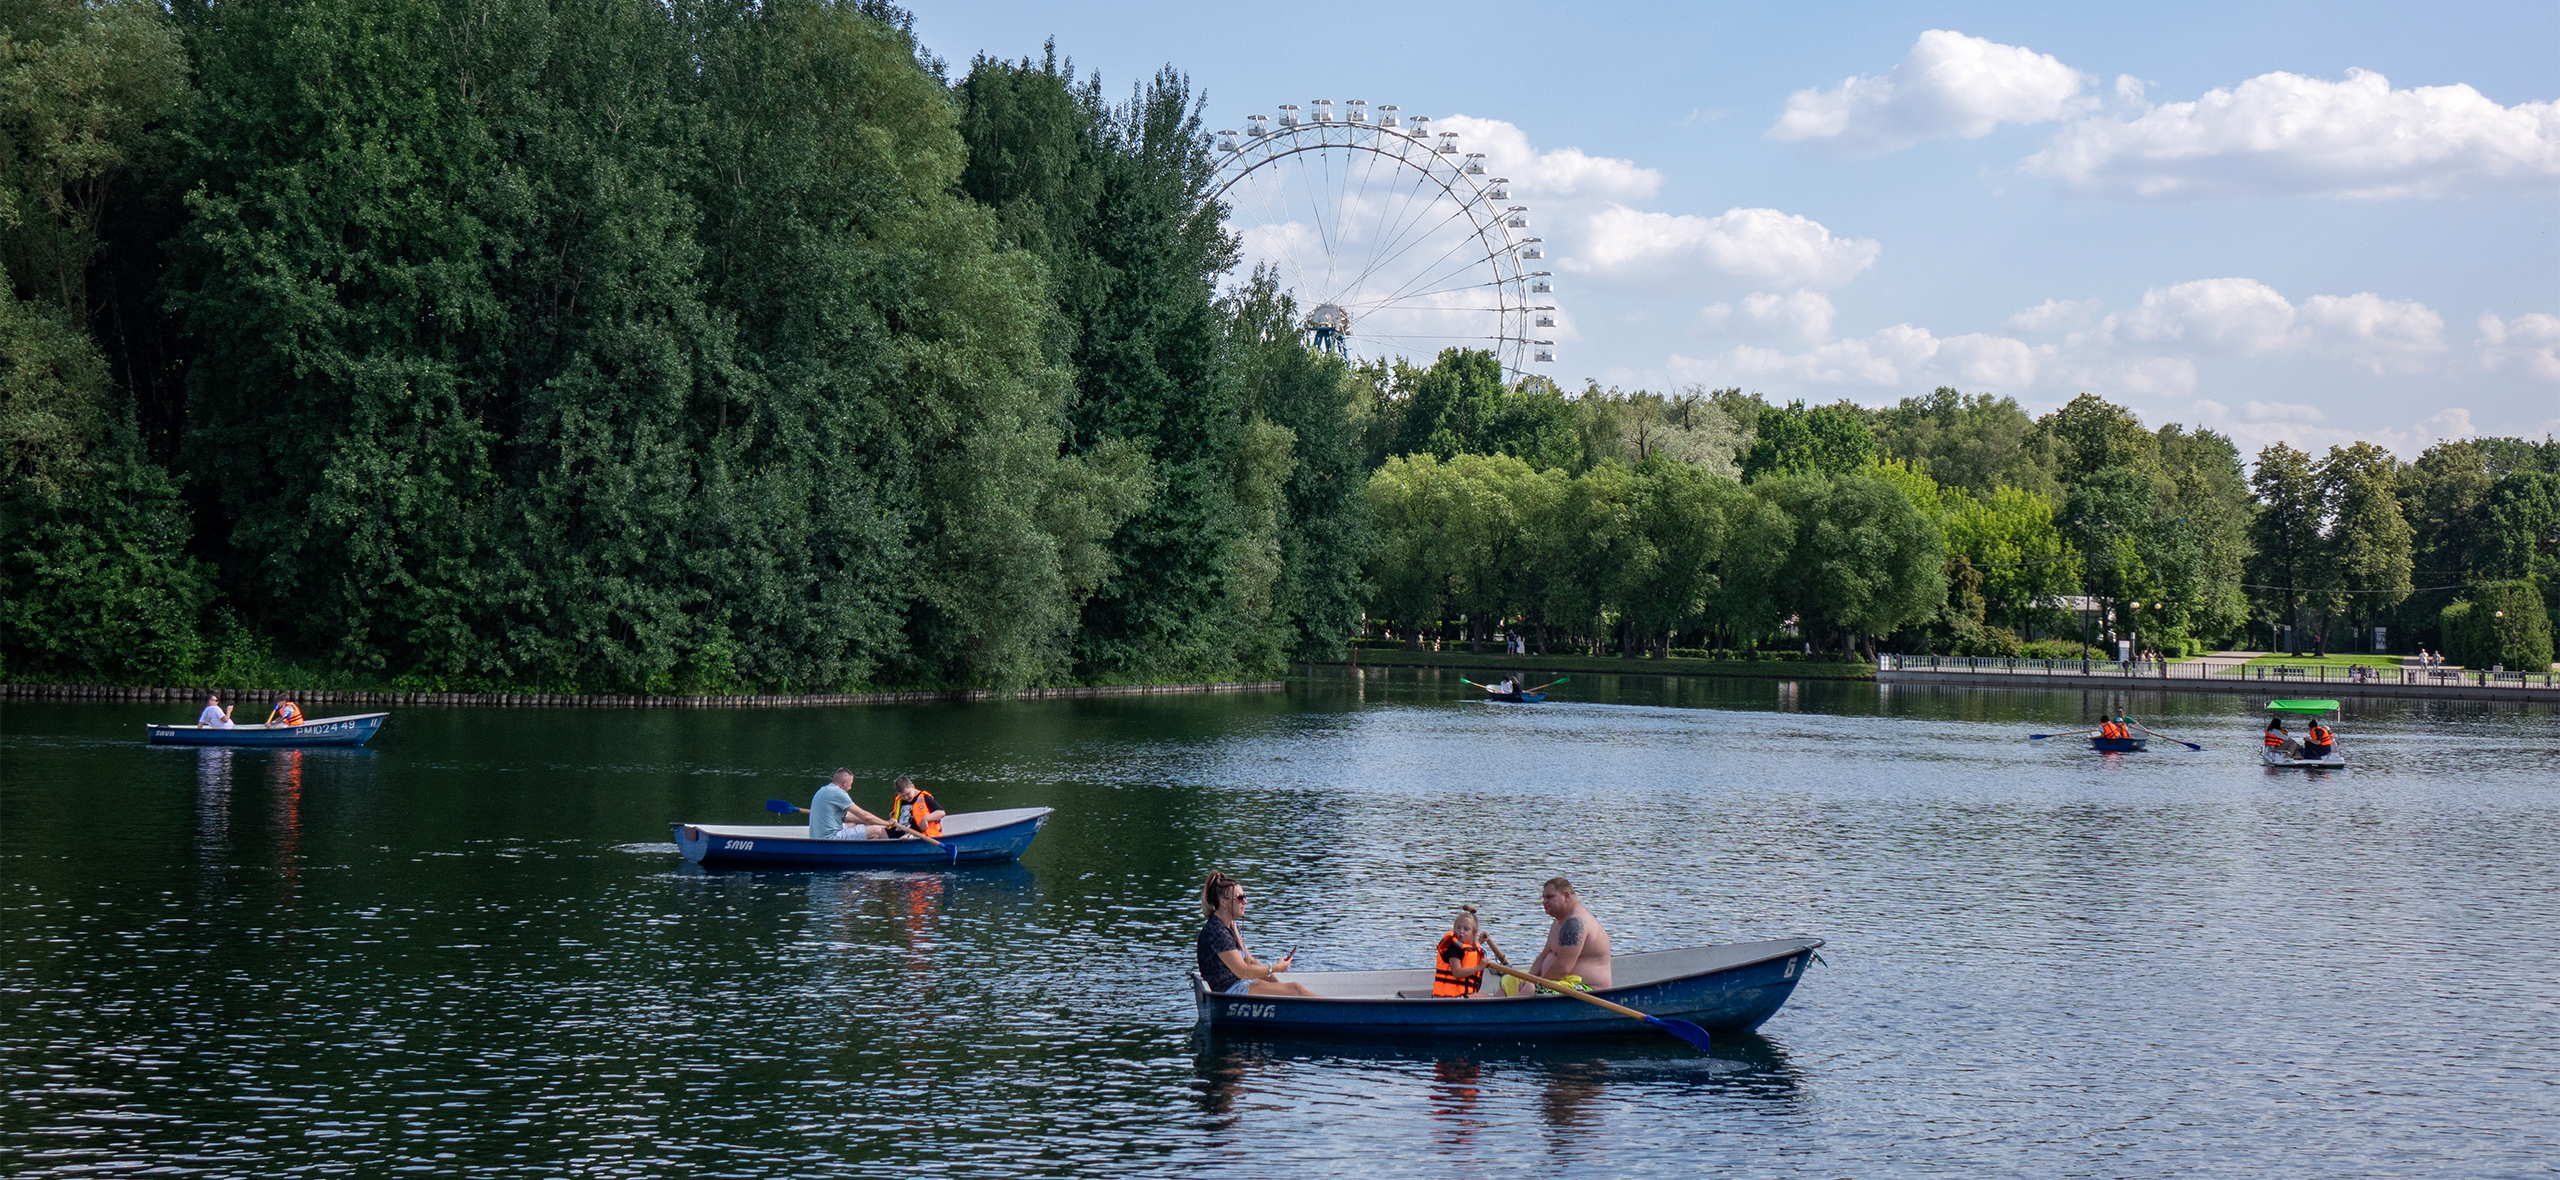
[914,0,2560,458]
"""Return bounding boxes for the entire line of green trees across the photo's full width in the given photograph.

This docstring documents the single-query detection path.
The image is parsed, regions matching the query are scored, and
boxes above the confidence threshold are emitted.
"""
[0,0,2560,691]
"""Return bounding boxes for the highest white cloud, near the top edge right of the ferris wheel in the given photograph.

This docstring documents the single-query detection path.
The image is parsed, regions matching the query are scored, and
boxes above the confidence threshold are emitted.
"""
[1769,28,2094,154]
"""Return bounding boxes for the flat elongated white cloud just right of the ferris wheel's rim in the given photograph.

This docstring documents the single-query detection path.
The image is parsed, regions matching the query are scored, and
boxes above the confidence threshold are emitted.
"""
[1562,205,1884,289]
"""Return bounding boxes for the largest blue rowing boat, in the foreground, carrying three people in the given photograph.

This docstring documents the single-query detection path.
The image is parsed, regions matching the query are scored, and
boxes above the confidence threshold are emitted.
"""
[1190,937,1823,1039]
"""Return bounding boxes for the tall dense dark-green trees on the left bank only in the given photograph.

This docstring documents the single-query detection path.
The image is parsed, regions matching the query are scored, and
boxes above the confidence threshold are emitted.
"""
[0,0,1364,691]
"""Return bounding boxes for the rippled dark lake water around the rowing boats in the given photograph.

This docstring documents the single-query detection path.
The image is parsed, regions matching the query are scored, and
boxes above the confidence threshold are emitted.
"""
[0,671,2560,1177]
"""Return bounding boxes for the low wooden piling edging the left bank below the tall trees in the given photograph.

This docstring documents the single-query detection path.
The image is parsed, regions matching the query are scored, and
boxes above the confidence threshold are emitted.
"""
[0,681,1280,714]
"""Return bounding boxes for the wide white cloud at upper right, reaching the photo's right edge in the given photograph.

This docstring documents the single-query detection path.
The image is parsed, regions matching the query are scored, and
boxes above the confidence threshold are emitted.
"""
[2022,69,2560,200]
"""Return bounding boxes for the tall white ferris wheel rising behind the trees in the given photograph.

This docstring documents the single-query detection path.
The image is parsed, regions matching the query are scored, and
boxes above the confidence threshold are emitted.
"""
[1208,97,1556,379]
